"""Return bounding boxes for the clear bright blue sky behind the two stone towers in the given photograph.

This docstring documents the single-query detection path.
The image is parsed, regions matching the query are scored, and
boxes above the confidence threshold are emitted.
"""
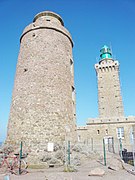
[0,0,135,141]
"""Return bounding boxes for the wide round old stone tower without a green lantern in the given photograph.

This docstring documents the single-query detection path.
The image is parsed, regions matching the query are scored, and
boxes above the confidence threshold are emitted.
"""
[6,11,76,152]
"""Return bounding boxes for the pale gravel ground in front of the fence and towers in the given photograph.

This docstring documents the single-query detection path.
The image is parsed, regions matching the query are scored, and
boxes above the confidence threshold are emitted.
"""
[0,160,135,180]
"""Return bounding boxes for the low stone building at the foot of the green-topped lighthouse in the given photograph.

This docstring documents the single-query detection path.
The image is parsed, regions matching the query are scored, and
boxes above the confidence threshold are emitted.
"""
[77,116,135,153]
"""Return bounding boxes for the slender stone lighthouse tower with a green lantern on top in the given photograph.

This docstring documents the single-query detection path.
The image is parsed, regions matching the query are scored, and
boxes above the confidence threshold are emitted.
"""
[95,46,124,118]
